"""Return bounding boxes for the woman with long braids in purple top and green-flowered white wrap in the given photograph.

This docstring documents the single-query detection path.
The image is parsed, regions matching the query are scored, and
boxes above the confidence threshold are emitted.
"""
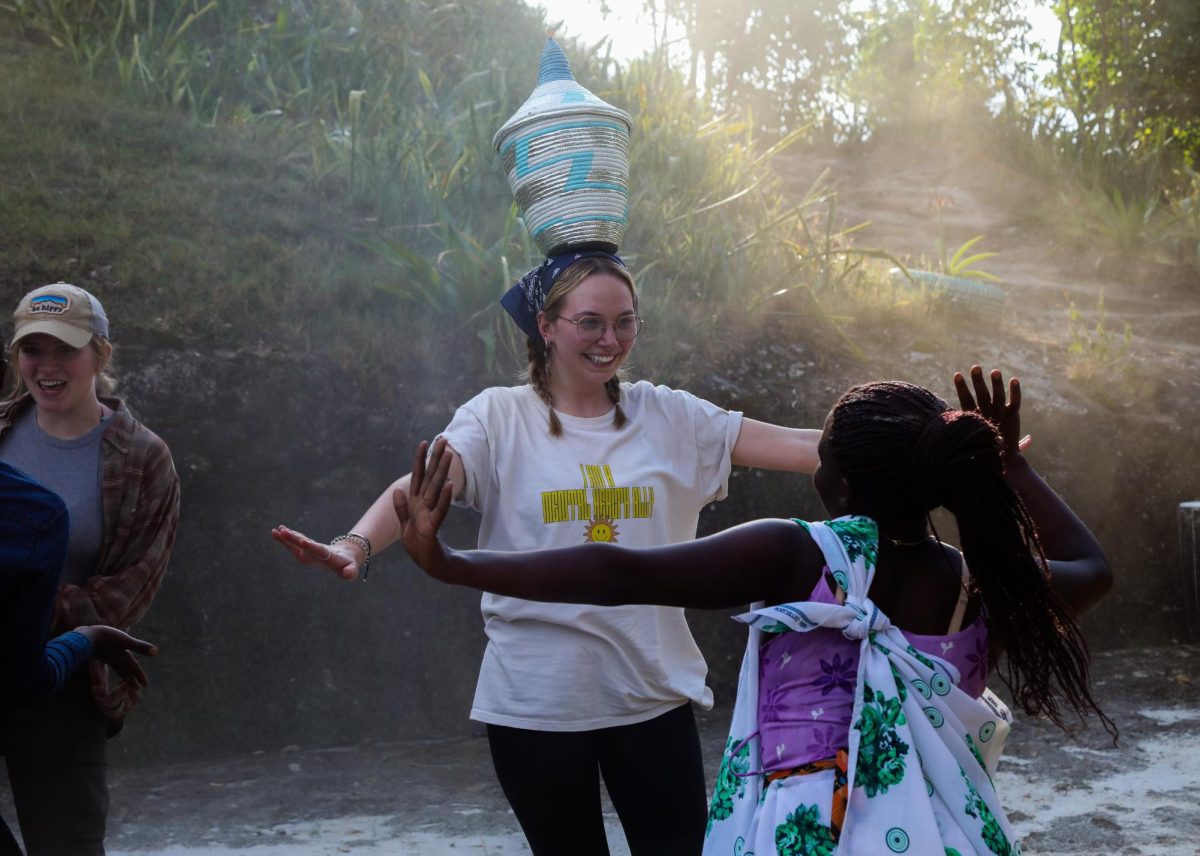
[395,366,1115,856]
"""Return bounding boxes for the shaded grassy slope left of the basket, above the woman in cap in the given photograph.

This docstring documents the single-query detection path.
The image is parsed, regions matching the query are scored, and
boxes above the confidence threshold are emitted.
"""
[0,0,541,381]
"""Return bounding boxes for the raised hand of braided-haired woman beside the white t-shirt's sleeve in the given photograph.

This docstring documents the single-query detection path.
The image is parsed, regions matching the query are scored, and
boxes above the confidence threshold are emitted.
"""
[391,438,452,579]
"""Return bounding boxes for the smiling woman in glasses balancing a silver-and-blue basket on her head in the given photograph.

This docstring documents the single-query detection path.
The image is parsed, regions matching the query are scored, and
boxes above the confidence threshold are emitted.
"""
[274,40,820,856]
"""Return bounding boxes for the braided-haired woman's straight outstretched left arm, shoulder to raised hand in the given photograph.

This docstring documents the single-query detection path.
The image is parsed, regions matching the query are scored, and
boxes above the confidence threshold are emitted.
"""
[394,441,823,609]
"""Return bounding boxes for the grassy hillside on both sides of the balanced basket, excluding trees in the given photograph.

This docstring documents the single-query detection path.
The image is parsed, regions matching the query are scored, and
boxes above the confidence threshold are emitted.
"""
[0,0,902,384]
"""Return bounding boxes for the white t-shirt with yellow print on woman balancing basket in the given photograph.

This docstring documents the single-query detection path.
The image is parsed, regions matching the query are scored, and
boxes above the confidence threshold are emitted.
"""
[443,381,742,731]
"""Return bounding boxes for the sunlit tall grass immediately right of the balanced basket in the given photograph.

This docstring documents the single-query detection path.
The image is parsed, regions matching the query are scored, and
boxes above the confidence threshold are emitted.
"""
[580,55,894,377]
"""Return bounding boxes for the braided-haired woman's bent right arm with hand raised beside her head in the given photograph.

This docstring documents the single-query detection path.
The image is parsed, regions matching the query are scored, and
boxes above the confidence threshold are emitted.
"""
[954,366,1112,615]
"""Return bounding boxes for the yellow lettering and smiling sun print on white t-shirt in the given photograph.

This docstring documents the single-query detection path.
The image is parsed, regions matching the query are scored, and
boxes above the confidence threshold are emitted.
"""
[541,463,654,544]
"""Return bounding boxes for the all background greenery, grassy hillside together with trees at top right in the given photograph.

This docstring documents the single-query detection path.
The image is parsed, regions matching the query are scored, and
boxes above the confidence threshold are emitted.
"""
[0,0,1200,381]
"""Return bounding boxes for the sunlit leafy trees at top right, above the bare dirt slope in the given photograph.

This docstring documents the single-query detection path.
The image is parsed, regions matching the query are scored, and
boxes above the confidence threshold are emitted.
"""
[662,0,1200,274]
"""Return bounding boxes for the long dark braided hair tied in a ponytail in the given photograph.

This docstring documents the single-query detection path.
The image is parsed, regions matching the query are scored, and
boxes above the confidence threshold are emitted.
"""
[829,382,1116,736]
